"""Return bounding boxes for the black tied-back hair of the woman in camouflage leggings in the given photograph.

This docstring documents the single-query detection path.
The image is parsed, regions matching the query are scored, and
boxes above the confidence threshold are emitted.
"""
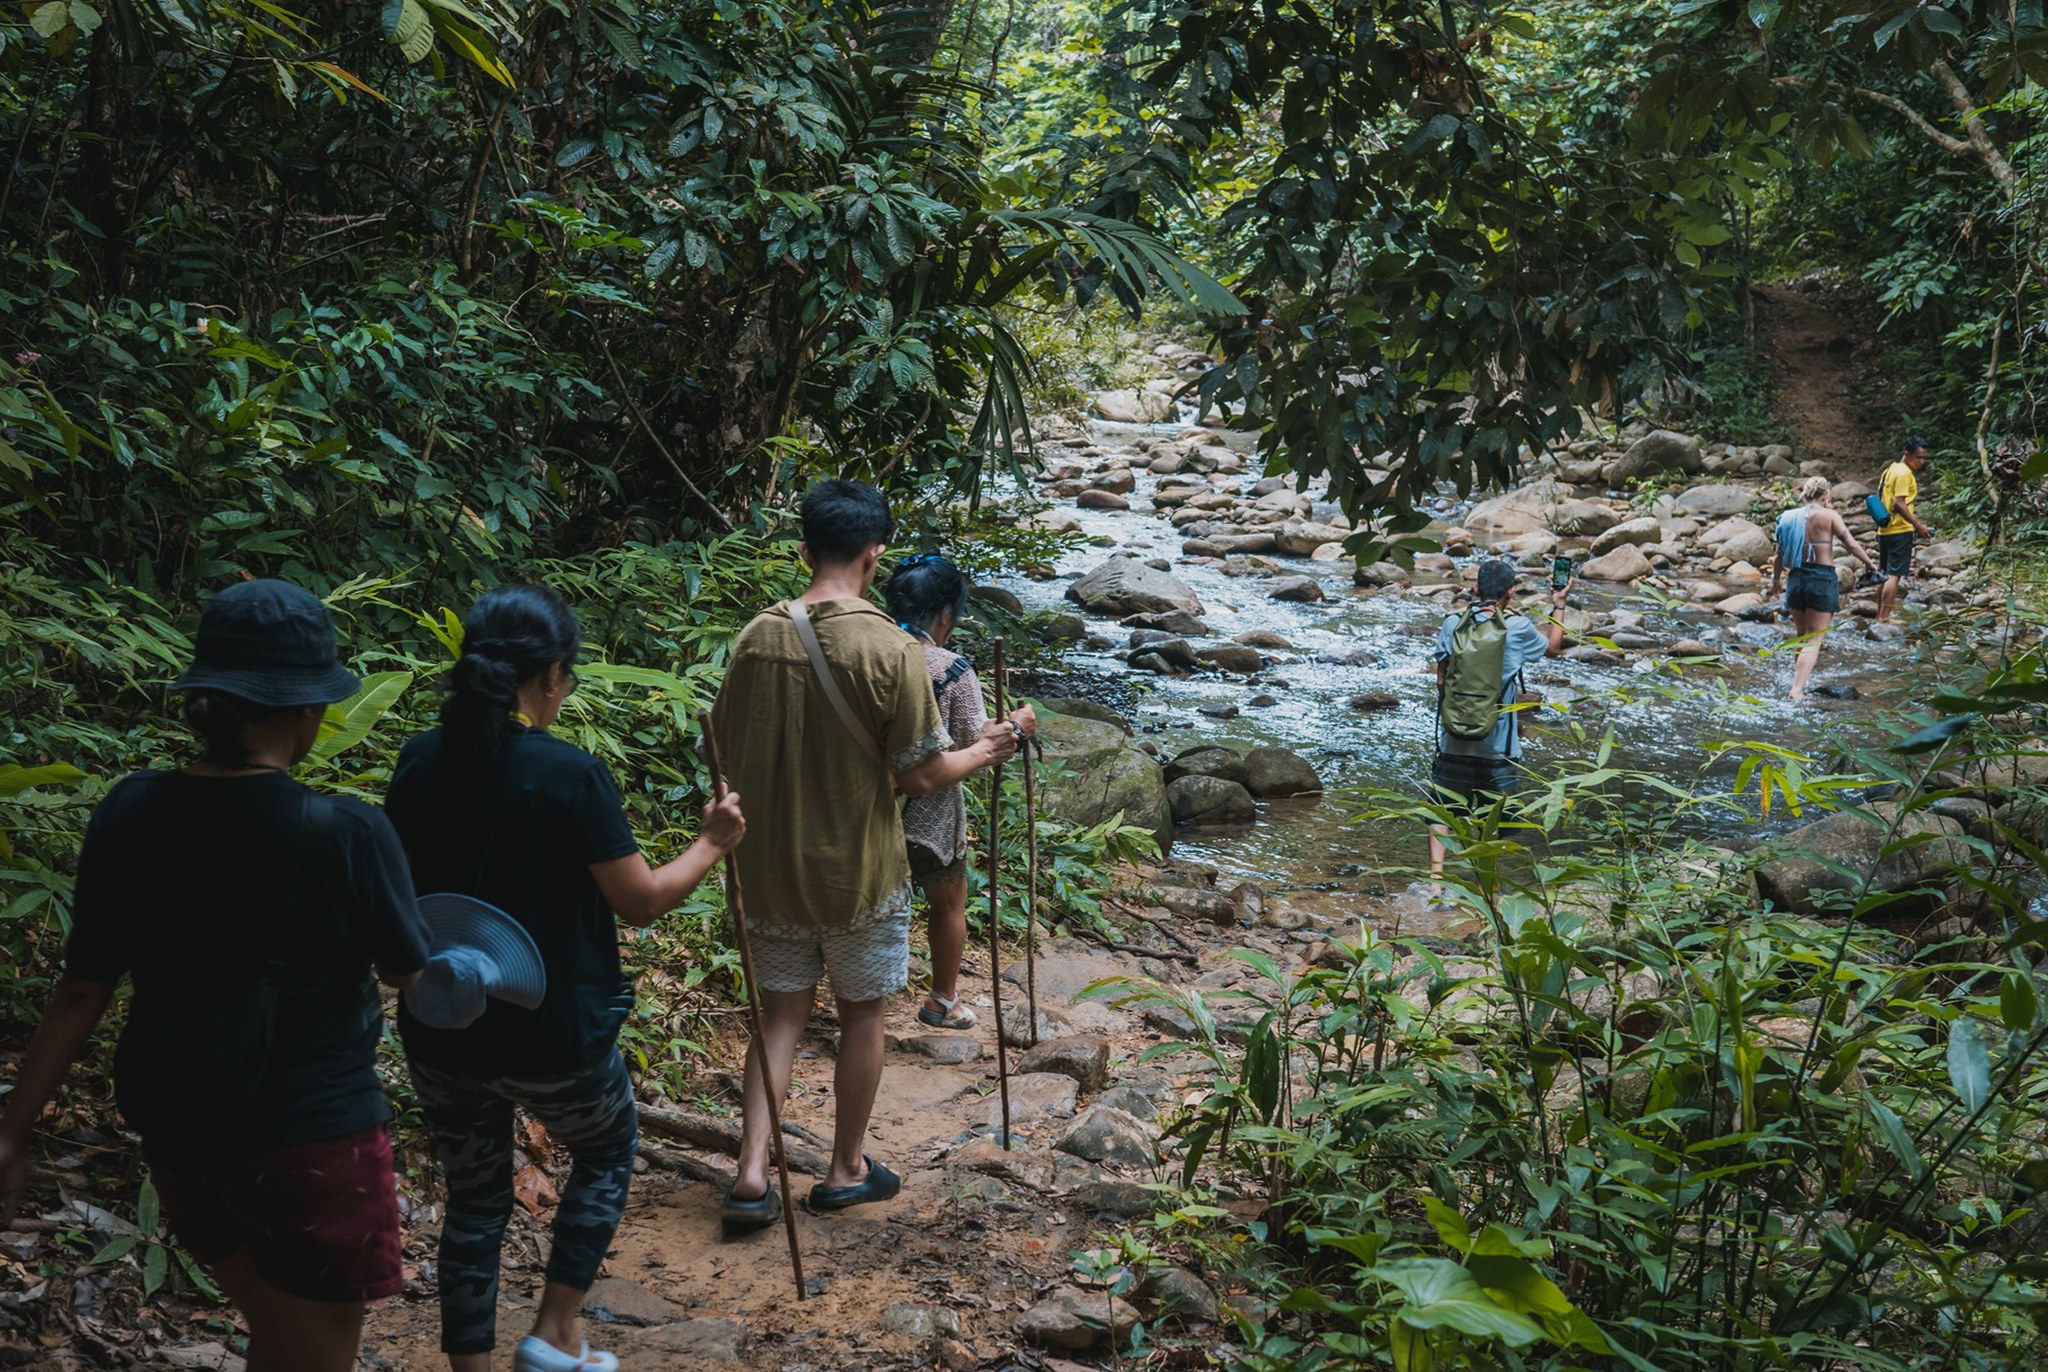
[440,586,584,762]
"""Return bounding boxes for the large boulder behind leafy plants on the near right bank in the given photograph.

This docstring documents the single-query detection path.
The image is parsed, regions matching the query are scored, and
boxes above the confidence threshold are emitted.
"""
[1757,801,1970,915]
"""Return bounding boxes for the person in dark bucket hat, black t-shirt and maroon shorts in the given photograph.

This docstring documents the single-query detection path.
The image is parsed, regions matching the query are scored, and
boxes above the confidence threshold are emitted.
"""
[0,582,428,1372]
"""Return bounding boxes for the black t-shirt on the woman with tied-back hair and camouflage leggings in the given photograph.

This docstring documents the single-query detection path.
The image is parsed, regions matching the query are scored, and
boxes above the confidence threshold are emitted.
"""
[385,729,639,1077]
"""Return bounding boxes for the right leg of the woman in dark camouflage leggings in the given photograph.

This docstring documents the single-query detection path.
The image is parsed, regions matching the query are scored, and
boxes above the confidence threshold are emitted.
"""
[508,1048,639,1354]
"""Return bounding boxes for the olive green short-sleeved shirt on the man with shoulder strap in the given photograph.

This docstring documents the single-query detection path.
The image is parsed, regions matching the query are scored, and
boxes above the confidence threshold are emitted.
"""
[713,600,946,938]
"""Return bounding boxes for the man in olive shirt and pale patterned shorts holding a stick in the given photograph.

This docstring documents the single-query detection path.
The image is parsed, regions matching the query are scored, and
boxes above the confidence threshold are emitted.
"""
[713,479,1020,1233]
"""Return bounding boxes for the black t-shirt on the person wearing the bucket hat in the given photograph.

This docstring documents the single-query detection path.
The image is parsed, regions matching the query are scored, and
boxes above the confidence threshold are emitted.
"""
[63,772,426,1163]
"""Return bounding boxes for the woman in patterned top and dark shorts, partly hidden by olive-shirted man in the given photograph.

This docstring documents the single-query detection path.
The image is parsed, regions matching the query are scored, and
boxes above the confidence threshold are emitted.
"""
[883,553,1038,1030]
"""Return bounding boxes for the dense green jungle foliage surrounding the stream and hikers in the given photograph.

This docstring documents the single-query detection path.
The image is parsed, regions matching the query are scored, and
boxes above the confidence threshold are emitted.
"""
[0,0,2048,1372]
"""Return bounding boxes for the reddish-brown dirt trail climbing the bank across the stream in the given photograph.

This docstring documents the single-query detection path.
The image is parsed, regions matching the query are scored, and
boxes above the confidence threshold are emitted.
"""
[1755,276,1896,479]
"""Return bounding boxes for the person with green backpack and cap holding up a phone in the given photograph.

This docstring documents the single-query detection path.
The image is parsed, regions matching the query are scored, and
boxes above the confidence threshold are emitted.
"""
[1430,559,1569,895]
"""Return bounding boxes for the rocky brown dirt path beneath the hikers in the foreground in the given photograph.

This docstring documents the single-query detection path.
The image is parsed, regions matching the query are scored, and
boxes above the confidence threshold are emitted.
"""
[362,880,1298,1372]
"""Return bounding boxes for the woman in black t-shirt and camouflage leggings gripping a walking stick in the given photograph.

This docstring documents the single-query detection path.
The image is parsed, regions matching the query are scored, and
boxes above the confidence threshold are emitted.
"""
[385,586,745,1372]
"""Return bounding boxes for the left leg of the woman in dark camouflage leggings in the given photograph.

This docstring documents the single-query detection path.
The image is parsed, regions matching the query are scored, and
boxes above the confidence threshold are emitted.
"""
[412,1063,512,1372]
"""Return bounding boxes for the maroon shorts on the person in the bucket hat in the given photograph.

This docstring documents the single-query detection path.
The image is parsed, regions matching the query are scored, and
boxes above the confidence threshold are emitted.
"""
[152,1124,406,1300]
